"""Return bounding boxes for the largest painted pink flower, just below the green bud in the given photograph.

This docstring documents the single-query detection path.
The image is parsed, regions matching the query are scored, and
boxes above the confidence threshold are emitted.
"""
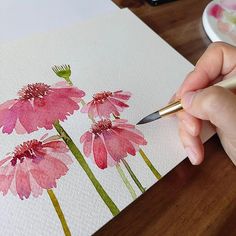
[0,82,85,134]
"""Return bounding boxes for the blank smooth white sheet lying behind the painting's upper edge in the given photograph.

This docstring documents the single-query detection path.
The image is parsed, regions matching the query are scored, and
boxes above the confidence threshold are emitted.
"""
[0,0,119,43]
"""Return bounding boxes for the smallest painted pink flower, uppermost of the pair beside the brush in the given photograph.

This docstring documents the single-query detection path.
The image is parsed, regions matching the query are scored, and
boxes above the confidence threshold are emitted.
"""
[81,90,131,118]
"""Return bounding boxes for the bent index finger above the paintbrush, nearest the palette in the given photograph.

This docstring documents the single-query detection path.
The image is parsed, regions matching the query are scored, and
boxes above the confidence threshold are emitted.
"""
[176,42,236,98]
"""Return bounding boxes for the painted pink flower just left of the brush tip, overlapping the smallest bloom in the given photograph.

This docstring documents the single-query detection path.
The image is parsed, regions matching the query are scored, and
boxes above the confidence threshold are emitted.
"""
[80,119,147,169]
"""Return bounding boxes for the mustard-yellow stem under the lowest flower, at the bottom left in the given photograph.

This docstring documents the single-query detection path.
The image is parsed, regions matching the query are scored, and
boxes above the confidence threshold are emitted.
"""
[47,189,71,236]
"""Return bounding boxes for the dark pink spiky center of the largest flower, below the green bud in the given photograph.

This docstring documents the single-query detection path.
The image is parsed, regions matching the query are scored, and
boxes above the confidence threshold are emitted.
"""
[18,83,50,100]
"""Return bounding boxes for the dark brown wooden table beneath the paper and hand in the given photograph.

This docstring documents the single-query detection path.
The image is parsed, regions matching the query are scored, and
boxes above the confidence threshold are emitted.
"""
[96,0,236,236]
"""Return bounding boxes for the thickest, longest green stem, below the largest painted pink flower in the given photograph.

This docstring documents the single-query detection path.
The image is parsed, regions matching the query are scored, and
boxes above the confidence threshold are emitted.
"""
[54,121,120,216]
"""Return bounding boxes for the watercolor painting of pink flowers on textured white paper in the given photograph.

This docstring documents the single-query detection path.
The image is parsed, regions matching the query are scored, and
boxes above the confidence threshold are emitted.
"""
[0,9,201,236]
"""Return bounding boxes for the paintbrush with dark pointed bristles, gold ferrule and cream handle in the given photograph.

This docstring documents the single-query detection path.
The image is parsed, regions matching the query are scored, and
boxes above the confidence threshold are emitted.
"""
[137,75,236,125]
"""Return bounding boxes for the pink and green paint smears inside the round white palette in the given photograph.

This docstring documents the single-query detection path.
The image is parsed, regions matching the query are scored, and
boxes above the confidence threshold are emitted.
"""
[208,0,236,43]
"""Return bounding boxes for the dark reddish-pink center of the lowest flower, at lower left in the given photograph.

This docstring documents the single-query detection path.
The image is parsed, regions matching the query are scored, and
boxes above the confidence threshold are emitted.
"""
[11,139,42,166]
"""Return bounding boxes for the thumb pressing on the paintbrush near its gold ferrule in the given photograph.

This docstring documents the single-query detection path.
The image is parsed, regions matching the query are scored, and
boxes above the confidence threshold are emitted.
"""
[181,86,236,138]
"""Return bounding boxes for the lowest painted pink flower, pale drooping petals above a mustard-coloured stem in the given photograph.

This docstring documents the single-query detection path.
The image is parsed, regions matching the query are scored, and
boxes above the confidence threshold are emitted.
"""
[0,136,72,200]
